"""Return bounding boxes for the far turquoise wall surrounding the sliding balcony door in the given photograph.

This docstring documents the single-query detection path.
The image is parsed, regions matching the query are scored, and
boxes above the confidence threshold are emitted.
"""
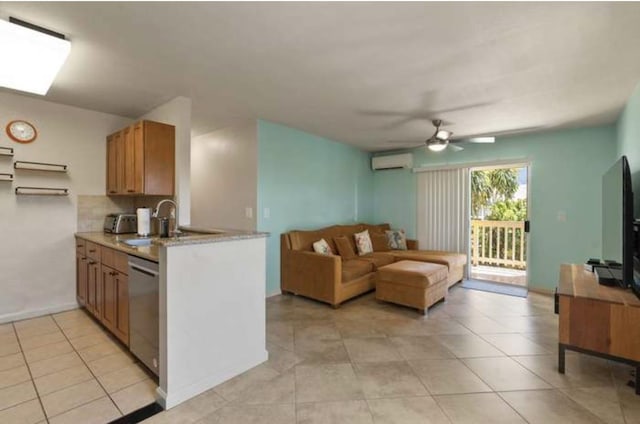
[373,126,616,290]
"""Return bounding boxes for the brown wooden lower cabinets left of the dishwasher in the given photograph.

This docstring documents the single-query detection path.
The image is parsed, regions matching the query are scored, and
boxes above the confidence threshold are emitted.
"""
[76,239,129,346]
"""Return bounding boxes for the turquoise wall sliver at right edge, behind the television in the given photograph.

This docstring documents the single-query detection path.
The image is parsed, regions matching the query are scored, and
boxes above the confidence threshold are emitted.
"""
[617,85,640,210]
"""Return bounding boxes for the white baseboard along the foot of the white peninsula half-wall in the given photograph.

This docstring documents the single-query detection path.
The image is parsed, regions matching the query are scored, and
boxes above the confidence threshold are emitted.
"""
[161,350,269,409]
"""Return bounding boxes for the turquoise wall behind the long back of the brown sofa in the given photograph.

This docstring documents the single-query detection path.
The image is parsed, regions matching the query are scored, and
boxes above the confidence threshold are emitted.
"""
[257,120,373,294]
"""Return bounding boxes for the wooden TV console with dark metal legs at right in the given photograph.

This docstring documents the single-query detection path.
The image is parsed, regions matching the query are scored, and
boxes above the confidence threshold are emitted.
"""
[558,264,640,395]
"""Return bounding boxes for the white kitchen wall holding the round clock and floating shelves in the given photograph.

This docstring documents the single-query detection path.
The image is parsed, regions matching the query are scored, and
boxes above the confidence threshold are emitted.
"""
[0,93,131,322]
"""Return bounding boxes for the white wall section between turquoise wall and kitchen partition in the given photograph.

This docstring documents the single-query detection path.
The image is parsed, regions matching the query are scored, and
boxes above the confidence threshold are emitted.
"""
[191,121,258,230]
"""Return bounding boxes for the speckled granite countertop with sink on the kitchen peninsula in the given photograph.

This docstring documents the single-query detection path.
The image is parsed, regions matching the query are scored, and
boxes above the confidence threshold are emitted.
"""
[75,226,269,262]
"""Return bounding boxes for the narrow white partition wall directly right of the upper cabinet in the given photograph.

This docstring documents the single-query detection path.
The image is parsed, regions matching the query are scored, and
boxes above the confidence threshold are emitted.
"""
[139,97,191,225]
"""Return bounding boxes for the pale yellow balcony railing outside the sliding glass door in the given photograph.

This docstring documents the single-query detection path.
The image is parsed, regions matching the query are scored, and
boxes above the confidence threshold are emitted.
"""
[471,220,527,269]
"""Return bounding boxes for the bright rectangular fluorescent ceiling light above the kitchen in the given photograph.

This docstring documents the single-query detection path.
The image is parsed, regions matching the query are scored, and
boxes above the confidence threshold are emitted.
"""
[0,20,71,95]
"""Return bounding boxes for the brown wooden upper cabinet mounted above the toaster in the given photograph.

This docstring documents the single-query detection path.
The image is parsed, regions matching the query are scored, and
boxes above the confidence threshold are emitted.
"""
[107,121,176,196]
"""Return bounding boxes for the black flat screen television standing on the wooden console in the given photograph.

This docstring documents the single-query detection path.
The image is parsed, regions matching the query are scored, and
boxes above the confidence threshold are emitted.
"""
[602,156,639,294]
